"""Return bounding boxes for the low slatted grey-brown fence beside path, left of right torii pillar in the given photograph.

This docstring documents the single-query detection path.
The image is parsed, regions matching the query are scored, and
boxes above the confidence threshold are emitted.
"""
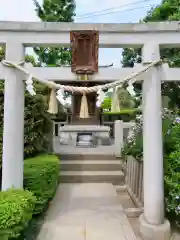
[124,156,144,208]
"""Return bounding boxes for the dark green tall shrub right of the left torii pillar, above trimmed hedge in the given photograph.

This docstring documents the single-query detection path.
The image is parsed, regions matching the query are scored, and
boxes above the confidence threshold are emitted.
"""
[24,84,52,157]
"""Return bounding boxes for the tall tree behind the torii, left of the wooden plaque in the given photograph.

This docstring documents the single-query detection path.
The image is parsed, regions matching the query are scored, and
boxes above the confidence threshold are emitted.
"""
[33,0,76,66]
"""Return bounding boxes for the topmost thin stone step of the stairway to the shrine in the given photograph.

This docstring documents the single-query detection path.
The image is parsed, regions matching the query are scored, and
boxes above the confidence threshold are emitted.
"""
[59,153,121,161]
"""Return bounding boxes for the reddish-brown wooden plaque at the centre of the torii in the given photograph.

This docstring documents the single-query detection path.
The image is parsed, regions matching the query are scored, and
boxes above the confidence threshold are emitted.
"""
[70,30,99,74]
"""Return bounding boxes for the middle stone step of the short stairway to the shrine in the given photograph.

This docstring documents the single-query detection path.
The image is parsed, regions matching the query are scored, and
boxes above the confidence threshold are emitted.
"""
[60,160,122,171]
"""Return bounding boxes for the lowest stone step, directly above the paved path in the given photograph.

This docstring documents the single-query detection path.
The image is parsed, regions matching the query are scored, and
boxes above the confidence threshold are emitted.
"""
[60,171,124,185]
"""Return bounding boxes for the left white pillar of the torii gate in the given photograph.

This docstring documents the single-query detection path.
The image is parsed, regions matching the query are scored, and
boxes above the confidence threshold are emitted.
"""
[2,40,24,190]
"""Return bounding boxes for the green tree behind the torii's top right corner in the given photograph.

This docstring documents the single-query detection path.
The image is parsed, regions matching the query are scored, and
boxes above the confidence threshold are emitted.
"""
[122,0,180,108]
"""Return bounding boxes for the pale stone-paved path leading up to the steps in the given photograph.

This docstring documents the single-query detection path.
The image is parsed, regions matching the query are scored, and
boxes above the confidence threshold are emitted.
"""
[37,183,136,240]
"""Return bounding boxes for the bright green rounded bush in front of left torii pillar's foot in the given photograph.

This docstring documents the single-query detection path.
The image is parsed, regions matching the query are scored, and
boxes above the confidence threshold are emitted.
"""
[0,189,36,240]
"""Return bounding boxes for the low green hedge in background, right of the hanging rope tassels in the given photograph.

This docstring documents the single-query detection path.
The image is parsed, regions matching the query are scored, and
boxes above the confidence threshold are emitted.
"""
[102,108,141,122]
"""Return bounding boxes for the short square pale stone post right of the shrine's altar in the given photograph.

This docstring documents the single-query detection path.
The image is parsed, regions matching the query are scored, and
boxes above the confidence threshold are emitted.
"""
[114,120,123,157]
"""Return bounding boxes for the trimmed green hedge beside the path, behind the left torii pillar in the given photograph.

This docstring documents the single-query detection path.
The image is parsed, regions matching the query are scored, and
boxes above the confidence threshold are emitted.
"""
[24,155,60,214]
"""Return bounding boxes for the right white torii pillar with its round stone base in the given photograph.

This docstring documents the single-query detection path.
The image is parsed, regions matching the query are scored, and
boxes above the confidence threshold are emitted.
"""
[140,43,170,240]
